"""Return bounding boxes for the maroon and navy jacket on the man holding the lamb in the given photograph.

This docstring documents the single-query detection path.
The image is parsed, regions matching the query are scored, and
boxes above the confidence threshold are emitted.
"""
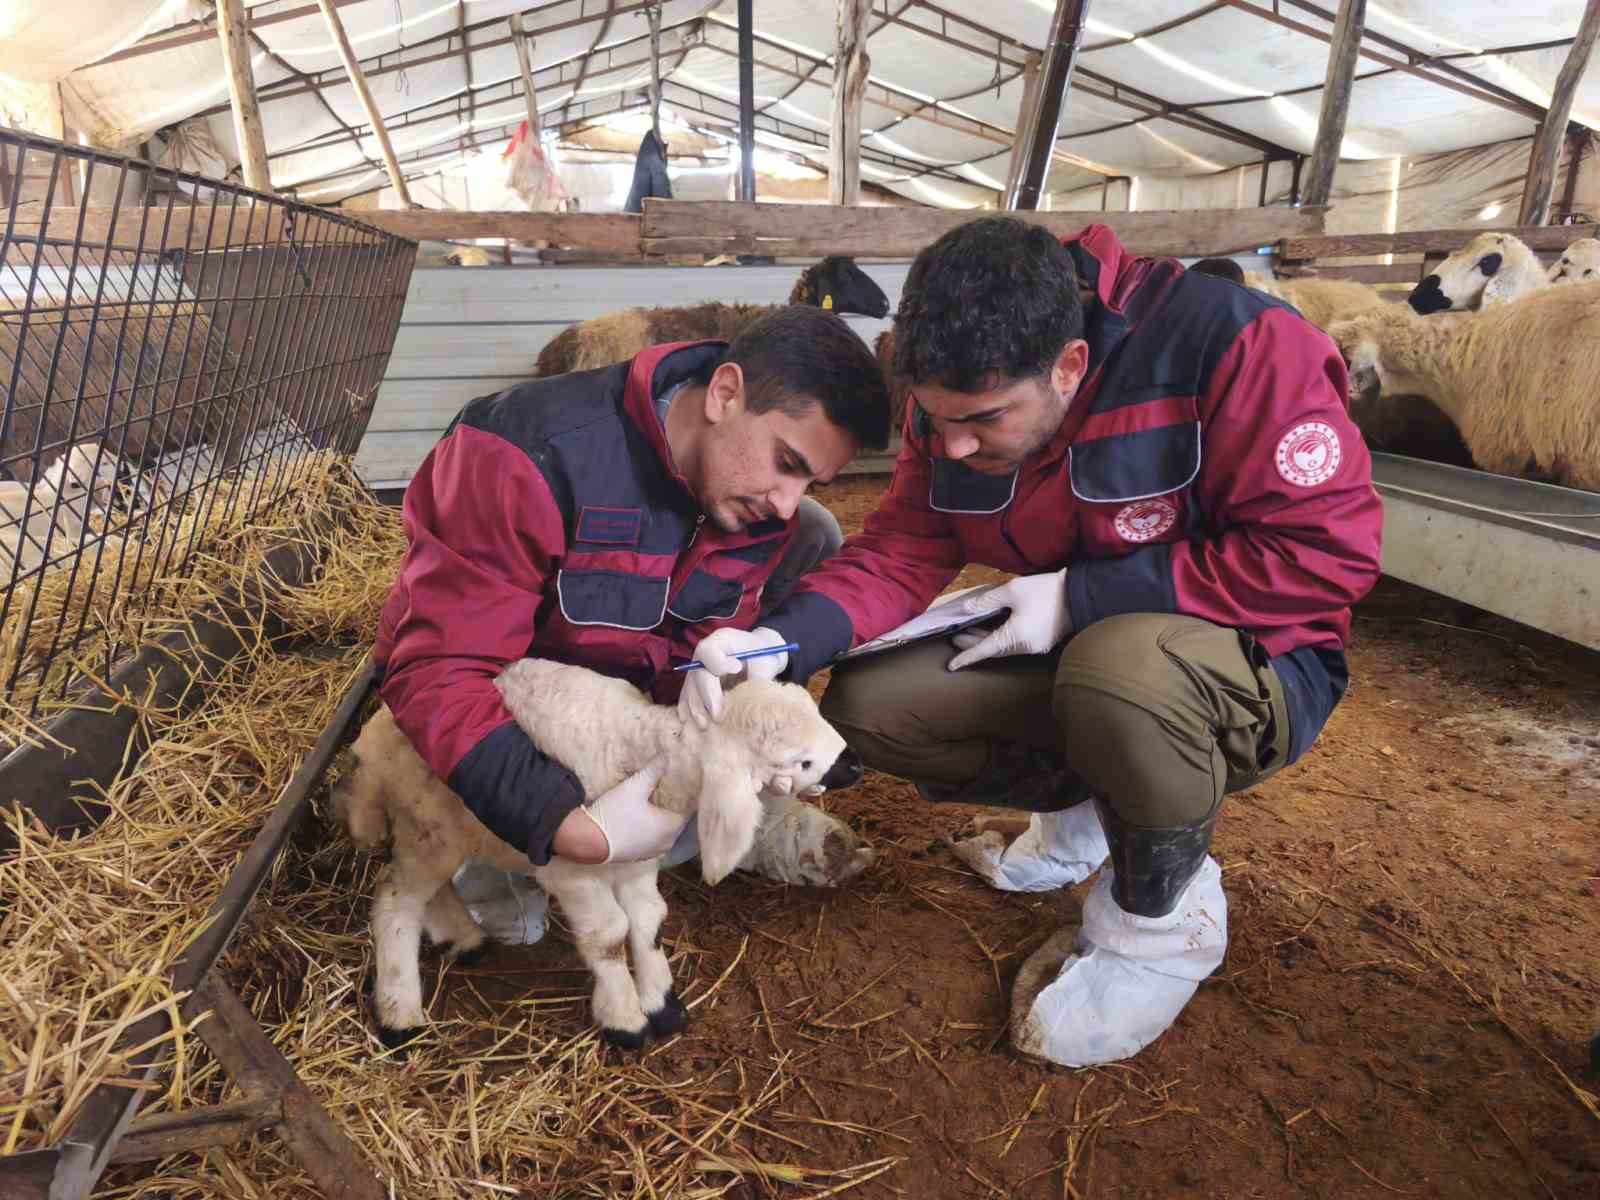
[373,342,794,864]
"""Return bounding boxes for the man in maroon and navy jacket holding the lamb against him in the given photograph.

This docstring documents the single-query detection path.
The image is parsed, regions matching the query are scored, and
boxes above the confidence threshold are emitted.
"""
[374,306,888,896]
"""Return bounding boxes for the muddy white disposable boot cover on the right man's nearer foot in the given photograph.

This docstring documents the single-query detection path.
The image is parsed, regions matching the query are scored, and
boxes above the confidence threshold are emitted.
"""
[1011,858,1227,1067]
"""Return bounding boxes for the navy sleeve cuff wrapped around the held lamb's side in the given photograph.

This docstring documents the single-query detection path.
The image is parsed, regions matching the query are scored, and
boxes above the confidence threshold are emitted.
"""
[448,722,584,867]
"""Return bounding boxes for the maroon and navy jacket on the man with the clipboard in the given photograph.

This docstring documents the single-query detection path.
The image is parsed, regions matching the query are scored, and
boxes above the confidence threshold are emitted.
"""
[762,226,1382,755]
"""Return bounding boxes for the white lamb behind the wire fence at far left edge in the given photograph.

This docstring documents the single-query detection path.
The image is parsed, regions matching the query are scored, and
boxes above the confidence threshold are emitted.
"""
[0,442,117,587]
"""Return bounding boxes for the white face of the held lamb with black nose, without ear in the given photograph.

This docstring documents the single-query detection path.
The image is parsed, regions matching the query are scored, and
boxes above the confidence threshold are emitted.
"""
[722,680,861,795]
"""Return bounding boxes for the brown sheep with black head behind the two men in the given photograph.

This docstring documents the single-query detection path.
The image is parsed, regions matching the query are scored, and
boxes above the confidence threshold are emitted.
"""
[533,254,890,378]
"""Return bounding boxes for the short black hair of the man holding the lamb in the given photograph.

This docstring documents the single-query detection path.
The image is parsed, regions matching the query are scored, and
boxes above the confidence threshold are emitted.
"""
[722,304,890,450]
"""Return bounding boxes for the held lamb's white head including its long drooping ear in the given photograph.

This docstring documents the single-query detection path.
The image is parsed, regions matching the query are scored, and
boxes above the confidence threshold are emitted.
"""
[696,680,861,883]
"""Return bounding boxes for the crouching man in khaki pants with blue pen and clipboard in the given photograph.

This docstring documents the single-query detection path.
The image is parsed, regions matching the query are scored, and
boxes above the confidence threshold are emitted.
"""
[691,218,1381,1066]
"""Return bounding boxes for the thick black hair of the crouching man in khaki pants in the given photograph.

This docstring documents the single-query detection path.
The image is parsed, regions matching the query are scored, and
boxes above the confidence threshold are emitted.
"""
[894,216,1083,392]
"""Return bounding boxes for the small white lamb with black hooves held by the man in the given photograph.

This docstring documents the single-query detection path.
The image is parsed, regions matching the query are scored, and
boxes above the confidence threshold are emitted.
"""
[334,659,861,1048]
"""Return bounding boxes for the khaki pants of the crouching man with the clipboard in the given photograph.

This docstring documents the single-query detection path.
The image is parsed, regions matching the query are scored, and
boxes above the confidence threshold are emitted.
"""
[822,613,1290,829]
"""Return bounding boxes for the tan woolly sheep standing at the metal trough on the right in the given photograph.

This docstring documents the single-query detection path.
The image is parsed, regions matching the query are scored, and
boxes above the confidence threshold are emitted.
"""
[1328,282,1600,491]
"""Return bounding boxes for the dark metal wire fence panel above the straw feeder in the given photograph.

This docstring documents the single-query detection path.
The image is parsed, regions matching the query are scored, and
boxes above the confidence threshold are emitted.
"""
[0,128,416,720]
